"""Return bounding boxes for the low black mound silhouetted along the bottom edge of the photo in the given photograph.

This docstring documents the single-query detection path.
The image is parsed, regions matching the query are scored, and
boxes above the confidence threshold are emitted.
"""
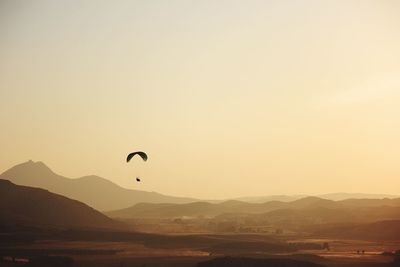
[196,257,324,267]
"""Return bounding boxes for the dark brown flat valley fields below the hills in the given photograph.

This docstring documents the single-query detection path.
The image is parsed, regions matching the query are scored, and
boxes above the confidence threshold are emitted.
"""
[0,229,400,267]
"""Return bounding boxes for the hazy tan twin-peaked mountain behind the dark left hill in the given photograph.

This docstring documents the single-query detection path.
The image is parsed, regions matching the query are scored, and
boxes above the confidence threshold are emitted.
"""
[0,161,196,211]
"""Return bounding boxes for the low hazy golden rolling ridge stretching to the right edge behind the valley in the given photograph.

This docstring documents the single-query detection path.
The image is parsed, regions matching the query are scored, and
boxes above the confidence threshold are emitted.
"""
[106,197,400,219]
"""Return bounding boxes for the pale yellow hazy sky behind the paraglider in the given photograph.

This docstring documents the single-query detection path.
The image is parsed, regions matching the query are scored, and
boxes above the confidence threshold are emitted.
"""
[0,0,400,198]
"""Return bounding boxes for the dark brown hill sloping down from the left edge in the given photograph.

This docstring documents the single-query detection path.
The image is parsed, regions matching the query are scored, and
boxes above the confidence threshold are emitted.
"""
[0,179,121,228]
